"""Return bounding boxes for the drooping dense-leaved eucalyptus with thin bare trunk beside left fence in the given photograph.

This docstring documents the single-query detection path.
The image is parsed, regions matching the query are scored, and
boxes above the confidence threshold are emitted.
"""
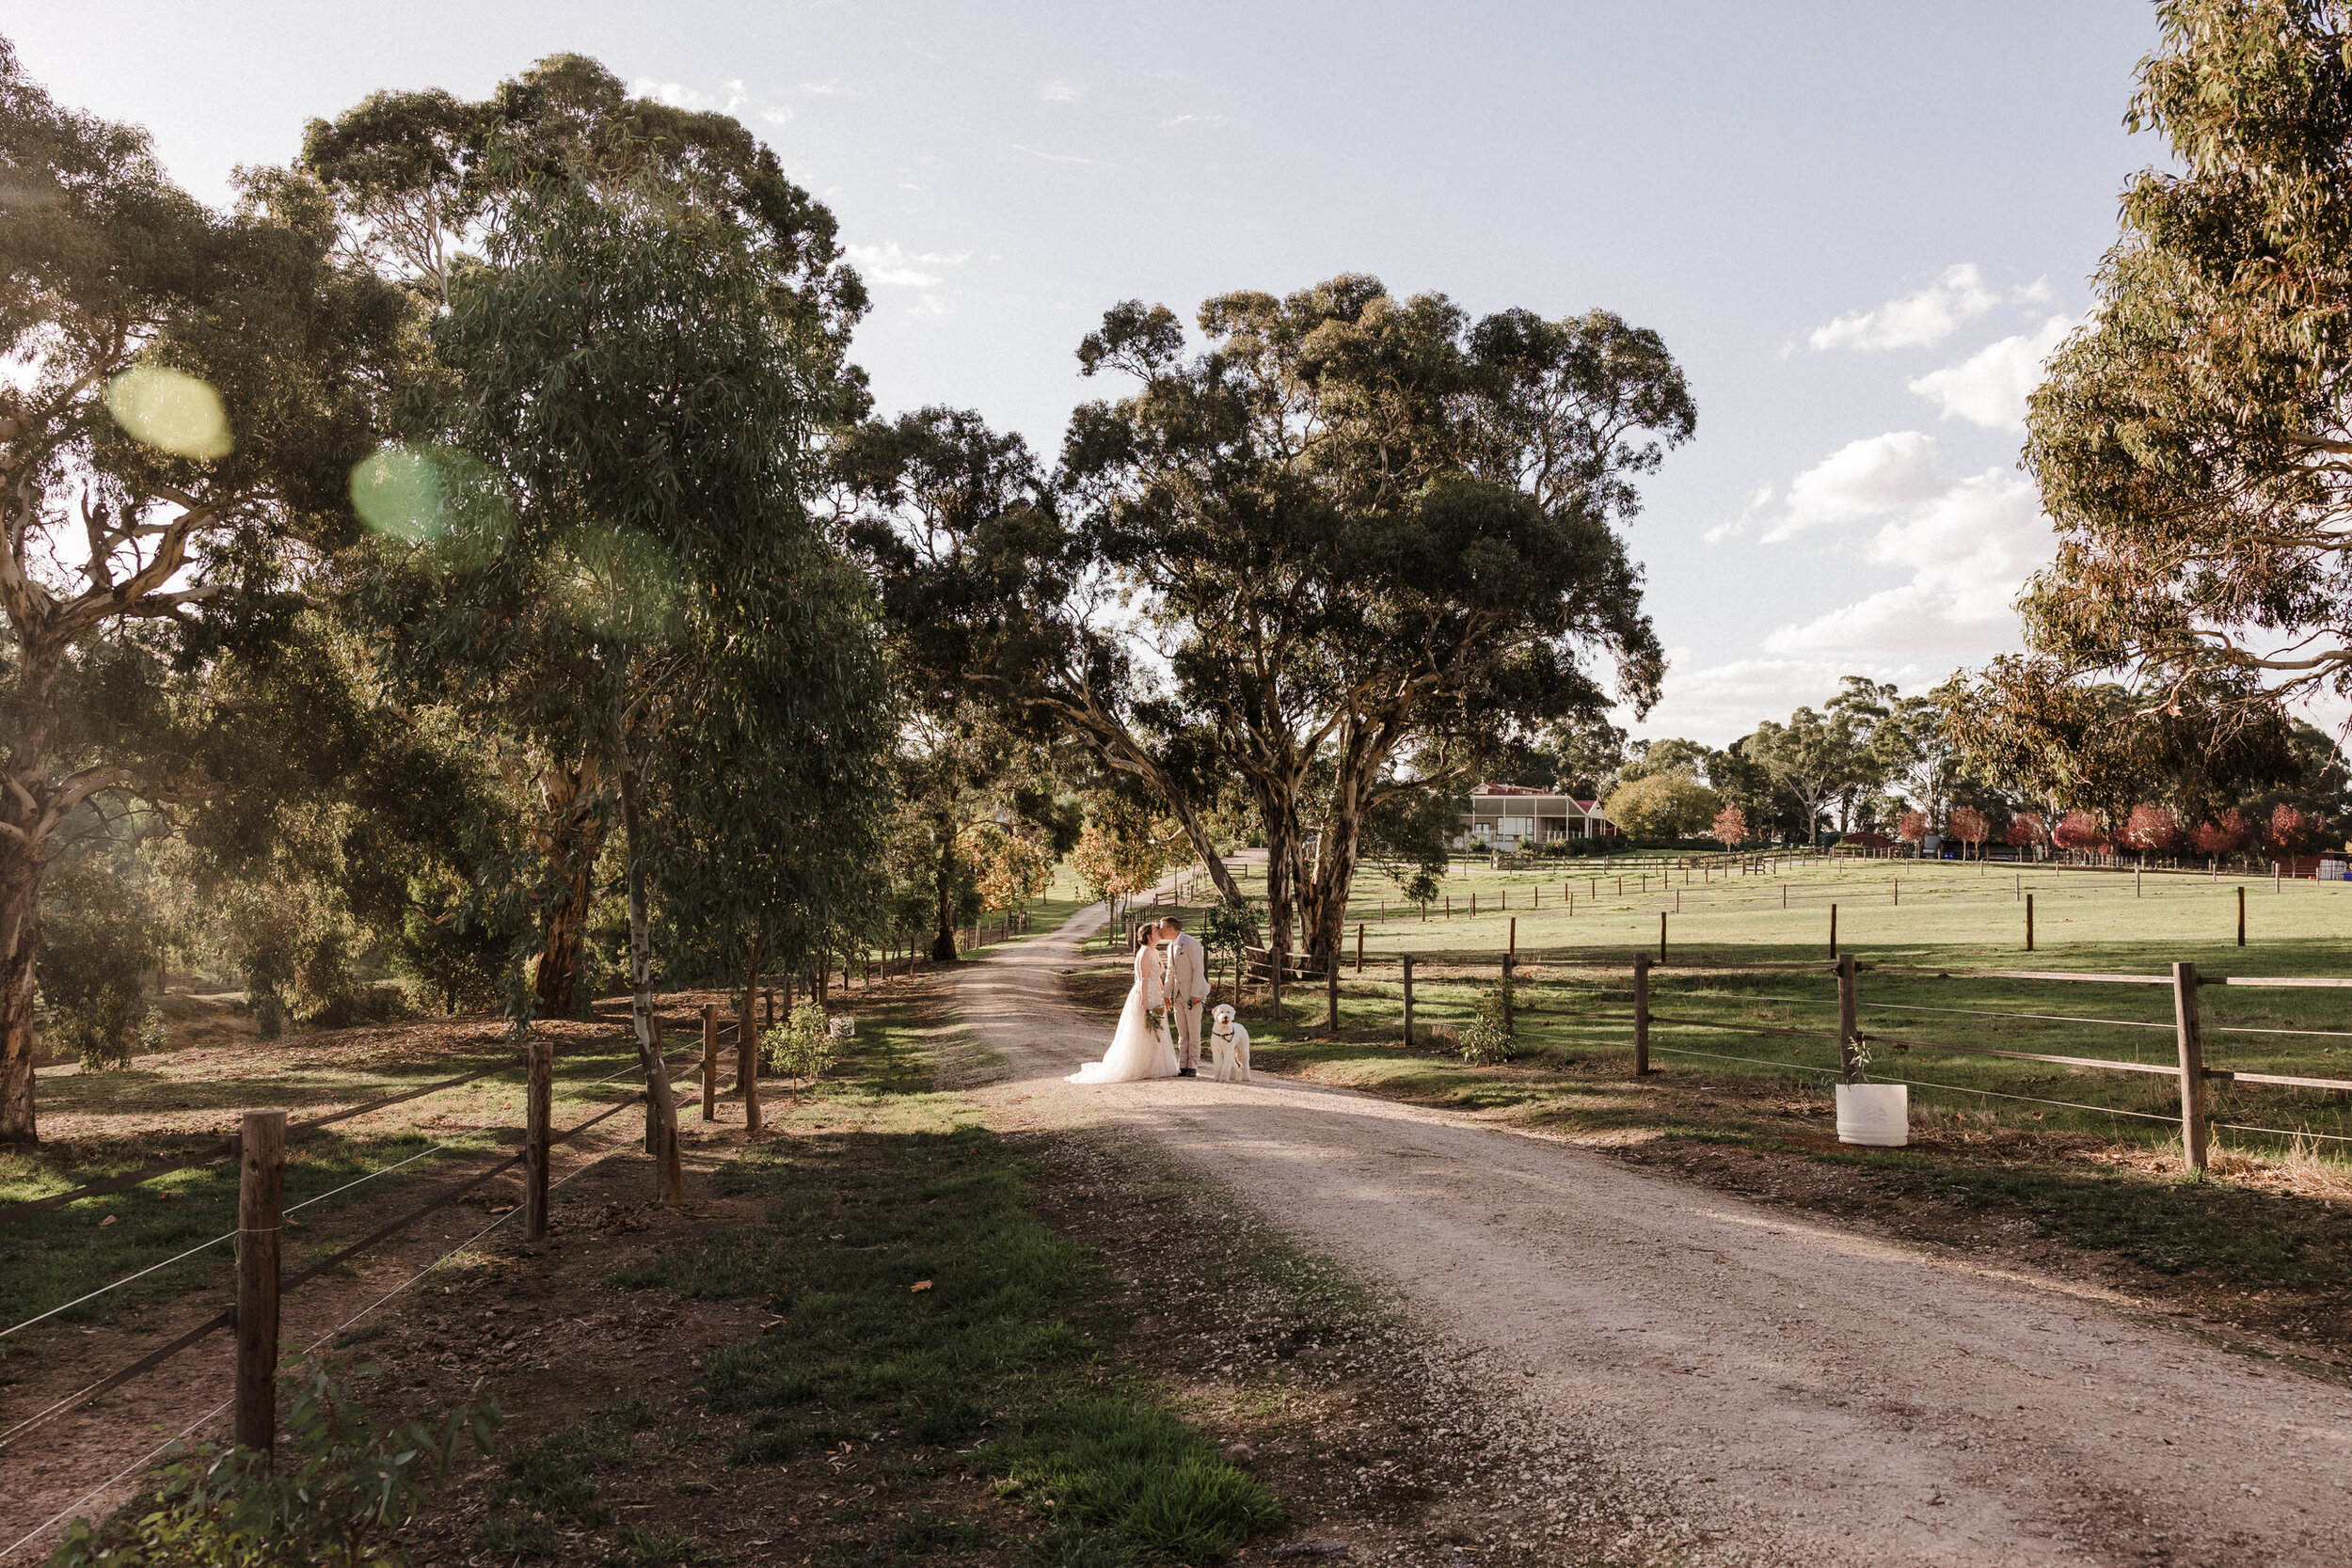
[356,176,887,1201]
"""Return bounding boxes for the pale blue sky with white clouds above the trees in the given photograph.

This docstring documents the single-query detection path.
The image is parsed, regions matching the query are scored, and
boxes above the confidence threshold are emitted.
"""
[0,0,2164,745]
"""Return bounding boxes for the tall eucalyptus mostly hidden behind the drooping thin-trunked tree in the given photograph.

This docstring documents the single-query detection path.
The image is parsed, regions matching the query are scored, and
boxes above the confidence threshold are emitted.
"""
[296,54,866,1016]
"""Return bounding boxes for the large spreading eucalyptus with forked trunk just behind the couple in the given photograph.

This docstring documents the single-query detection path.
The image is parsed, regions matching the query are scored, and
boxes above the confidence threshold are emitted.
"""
[1063,275,1696,955]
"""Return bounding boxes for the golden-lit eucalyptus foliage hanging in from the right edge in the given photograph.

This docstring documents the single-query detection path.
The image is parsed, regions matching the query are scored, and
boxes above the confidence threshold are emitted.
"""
[1983,0,2352,752]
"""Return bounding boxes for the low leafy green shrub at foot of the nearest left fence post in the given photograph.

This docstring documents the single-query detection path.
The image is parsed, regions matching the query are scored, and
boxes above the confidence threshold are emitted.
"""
[50,1364,503,1568]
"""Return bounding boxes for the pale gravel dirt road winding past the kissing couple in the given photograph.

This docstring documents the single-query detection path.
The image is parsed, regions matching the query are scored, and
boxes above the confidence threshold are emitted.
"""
[958,910,2352,1566]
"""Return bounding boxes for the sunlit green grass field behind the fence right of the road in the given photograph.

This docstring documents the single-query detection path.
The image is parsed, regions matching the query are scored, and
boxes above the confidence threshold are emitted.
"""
[1185,861,2352,1157]
